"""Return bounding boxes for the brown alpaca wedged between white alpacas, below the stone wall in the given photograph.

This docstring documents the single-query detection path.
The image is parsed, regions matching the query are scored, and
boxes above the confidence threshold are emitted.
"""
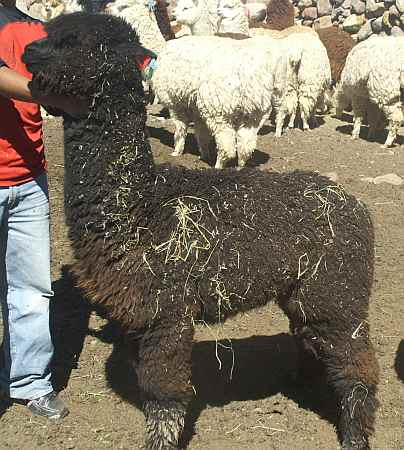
[317,26,355,84]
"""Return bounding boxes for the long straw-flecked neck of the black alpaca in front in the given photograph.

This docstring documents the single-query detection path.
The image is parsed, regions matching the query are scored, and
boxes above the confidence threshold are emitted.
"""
[65,90,155,253]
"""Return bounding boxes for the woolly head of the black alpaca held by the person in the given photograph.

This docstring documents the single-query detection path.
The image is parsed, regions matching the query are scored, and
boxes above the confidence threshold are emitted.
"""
[23,13,155,104]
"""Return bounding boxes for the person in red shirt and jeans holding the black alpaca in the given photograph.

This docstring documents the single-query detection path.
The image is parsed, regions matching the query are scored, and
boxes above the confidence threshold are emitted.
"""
[0,0,81,419]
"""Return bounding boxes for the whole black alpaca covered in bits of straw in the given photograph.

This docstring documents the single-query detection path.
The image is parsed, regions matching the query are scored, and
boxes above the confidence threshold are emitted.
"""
[24,13,378,449]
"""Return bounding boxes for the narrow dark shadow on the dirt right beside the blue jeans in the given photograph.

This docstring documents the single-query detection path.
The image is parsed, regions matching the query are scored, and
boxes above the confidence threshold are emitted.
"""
[50,266,92,391]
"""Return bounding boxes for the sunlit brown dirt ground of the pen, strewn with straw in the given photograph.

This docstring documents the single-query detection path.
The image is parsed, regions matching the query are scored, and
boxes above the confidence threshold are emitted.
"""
[0,108,404,450]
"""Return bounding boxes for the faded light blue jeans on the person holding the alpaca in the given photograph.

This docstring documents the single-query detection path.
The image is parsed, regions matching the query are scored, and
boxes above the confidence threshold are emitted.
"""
[0,174,53,399]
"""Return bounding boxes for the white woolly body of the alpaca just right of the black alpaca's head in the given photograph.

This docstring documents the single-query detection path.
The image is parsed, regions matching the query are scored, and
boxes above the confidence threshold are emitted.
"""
[152,36,275,116]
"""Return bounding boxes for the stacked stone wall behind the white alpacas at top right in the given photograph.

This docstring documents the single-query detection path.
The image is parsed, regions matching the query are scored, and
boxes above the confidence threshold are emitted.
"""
[293,0,404,41]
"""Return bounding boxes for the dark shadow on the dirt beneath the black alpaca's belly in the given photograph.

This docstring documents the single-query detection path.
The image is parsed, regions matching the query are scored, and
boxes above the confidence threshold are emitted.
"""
[102,333,337,446]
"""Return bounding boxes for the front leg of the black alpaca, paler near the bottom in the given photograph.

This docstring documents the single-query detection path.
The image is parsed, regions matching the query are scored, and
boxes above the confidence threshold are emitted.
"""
[136,316,194,450]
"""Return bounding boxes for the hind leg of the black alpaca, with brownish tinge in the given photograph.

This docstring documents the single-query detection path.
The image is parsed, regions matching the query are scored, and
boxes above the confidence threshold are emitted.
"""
[279,286,379,450]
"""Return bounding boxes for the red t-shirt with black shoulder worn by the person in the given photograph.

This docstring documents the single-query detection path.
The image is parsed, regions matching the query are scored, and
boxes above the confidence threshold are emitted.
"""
[0,7,46,186]
